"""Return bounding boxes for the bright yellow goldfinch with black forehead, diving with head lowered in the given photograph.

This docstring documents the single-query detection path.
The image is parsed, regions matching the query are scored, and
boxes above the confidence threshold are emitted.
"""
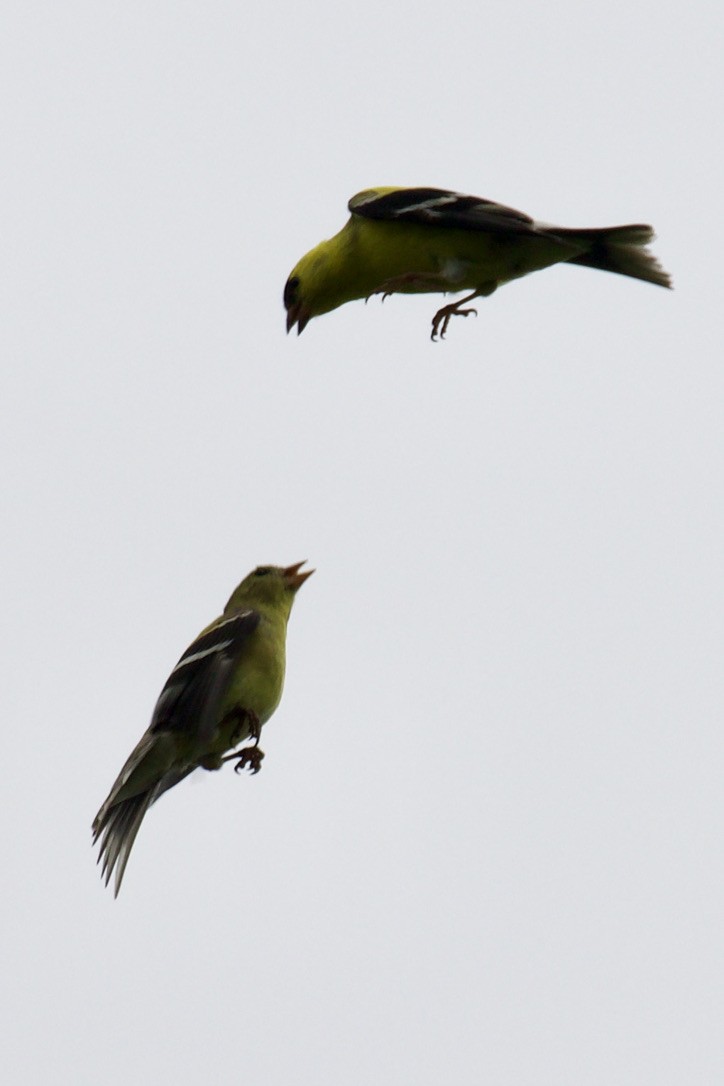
[284,188,671,340]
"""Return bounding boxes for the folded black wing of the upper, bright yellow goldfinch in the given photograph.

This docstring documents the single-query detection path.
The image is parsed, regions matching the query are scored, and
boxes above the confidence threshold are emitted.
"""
[347,189,538,236]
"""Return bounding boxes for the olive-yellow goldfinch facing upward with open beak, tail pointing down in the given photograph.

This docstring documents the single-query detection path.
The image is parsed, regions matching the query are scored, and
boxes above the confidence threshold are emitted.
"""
[93,561,314,897]
